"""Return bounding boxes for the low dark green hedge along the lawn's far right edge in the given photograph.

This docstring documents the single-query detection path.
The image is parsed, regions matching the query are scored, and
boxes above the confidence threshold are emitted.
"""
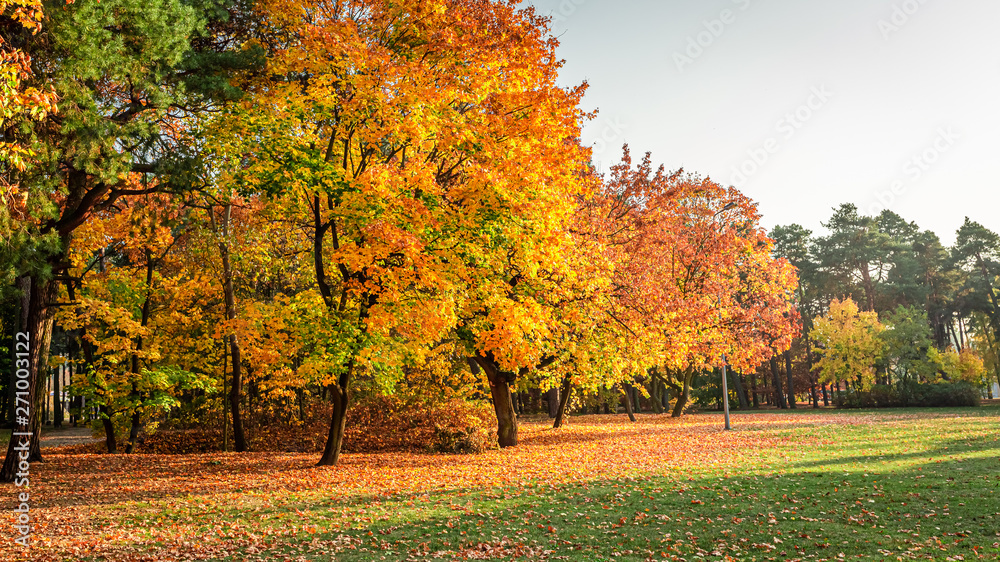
[834,382,980,408]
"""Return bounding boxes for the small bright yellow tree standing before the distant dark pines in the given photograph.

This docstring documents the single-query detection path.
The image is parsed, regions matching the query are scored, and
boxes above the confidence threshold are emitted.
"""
[811,298,885,391]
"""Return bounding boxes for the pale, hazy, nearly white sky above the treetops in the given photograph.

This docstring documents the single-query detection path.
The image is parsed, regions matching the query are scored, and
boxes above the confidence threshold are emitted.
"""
[527,0,1000,244]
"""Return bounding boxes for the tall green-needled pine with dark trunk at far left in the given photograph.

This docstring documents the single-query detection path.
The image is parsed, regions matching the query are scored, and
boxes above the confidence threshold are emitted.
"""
[0,0,262,481]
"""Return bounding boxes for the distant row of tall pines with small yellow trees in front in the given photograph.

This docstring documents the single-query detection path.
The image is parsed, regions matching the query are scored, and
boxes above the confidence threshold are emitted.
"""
[771,204,1000,407]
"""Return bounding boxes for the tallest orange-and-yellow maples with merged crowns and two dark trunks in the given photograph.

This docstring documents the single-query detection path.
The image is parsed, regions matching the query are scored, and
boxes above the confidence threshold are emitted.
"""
[232,1,583,464]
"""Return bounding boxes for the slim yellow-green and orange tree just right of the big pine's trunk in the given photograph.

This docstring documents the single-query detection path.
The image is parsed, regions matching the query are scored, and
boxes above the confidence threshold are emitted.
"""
[60,194,213,453]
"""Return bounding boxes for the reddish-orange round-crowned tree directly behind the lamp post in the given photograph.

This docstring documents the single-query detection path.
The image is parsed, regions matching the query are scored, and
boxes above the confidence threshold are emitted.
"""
[600,162,797,416]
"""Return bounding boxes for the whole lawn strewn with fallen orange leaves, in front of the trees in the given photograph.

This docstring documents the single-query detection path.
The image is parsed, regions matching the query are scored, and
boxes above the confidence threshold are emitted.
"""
[7,406,1000,561]
